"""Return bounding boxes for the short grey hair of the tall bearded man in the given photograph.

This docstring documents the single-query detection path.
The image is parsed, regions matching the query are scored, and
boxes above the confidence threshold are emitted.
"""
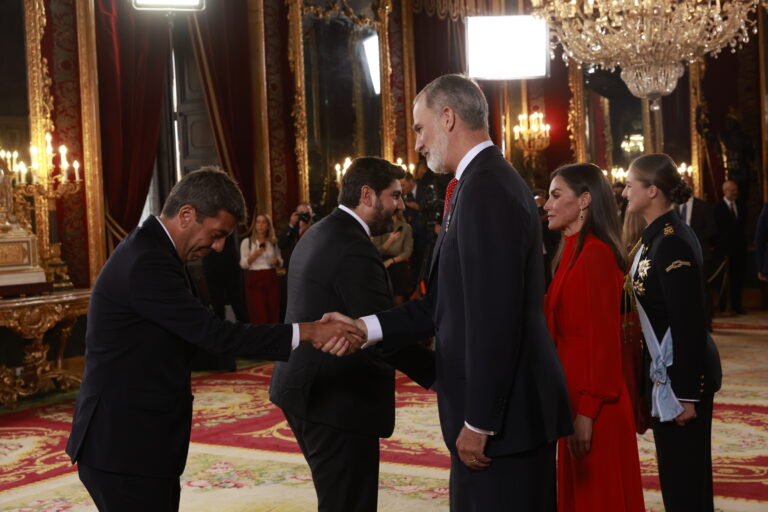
[413,74,488,132]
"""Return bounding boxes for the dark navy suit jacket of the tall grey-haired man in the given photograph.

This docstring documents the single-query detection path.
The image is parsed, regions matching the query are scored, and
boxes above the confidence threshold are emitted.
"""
[378,147,572,457]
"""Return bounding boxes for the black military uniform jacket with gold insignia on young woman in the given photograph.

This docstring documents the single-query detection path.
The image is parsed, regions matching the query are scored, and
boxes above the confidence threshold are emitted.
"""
[632,210,722,400]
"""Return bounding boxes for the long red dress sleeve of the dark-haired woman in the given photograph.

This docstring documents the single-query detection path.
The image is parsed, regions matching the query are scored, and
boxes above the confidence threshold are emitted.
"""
[559,239,624,419]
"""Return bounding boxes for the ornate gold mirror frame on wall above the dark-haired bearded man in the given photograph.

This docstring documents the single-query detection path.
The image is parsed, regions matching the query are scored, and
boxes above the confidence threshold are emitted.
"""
[286,0,395,201]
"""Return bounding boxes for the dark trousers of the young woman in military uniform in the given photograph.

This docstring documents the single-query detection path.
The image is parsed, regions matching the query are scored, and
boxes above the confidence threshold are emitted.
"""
[652,395,714,512]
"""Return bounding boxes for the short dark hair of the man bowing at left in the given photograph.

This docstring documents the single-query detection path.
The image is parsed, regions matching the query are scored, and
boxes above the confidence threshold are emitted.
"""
[162,166,247,222]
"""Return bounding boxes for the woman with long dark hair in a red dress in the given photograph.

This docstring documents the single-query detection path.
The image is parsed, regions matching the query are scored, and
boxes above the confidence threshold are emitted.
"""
[544,164,645,512]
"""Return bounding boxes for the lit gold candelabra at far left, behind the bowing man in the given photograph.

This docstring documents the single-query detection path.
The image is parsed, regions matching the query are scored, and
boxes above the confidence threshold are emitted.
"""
[5,133,83,290]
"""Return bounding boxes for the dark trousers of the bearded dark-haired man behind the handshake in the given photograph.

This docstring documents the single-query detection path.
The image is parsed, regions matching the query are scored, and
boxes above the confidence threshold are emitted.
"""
[283,411,379,512]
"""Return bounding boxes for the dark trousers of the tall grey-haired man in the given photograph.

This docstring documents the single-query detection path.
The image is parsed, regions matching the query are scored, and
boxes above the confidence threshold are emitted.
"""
[450,443,557,512]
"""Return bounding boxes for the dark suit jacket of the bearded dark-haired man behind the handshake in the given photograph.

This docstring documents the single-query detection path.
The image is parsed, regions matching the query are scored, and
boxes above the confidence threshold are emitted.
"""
[269,209,435,437]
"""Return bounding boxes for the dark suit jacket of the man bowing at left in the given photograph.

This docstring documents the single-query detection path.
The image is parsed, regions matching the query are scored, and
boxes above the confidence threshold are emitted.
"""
[67,217,292,477]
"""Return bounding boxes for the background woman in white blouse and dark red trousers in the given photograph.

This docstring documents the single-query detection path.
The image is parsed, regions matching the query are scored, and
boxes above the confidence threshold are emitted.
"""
[240,214,283,324]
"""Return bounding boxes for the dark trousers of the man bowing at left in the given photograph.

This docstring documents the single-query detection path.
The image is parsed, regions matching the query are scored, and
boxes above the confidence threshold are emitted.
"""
[77,463,181,512]
